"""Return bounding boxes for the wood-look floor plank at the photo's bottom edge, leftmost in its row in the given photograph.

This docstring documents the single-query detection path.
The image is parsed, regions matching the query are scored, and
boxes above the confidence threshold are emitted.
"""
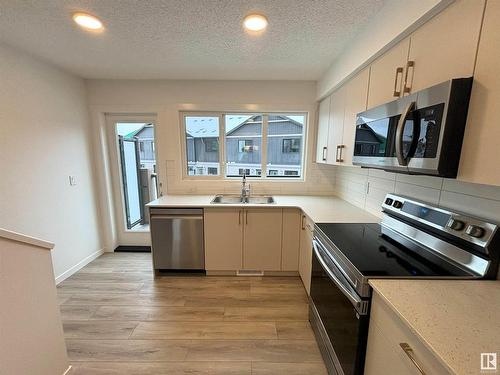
[71,362,252,375]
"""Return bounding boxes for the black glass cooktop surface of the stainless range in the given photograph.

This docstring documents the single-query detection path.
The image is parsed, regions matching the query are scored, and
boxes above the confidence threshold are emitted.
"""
[316,223,470,278]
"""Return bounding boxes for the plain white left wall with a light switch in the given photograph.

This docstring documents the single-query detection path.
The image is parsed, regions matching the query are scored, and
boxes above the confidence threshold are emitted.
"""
[0,45,101,276]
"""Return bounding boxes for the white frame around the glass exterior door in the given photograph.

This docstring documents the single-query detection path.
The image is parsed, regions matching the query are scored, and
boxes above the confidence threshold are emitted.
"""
[105,114,158,238]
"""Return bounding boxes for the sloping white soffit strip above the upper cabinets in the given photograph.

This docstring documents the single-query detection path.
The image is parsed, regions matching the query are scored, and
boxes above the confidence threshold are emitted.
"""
[317,0,454,99]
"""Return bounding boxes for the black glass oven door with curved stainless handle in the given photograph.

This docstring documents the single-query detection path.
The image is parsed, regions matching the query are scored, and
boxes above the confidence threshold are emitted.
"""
[310,238,369,375]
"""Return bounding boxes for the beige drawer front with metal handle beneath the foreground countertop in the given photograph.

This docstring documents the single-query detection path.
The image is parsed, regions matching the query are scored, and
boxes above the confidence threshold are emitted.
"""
[367,293,450,375]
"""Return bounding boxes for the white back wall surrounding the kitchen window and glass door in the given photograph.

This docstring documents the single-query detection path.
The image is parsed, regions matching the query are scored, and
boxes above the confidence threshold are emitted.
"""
[87,80,334,250]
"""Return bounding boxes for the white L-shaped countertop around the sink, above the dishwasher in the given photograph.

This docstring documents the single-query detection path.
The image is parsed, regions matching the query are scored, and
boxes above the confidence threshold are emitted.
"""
[147,195,380,223]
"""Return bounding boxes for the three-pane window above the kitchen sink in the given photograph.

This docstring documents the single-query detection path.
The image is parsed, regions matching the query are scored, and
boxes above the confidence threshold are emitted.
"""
[181,112,307,179]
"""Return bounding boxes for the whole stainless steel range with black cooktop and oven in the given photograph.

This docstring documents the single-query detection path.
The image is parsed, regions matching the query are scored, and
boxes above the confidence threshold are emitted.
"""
[310,194,500,375]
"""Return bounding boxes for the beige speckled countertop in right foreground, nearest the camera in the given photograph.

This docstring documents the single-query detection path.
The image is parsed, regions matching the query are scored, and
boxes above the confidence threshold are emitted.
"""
[370,279,500,374]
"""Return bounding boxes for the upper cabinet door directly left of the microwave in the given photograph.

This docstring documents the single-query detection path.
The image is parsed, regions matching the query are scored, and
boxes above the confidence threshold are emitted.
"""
[340,68,370,165]
